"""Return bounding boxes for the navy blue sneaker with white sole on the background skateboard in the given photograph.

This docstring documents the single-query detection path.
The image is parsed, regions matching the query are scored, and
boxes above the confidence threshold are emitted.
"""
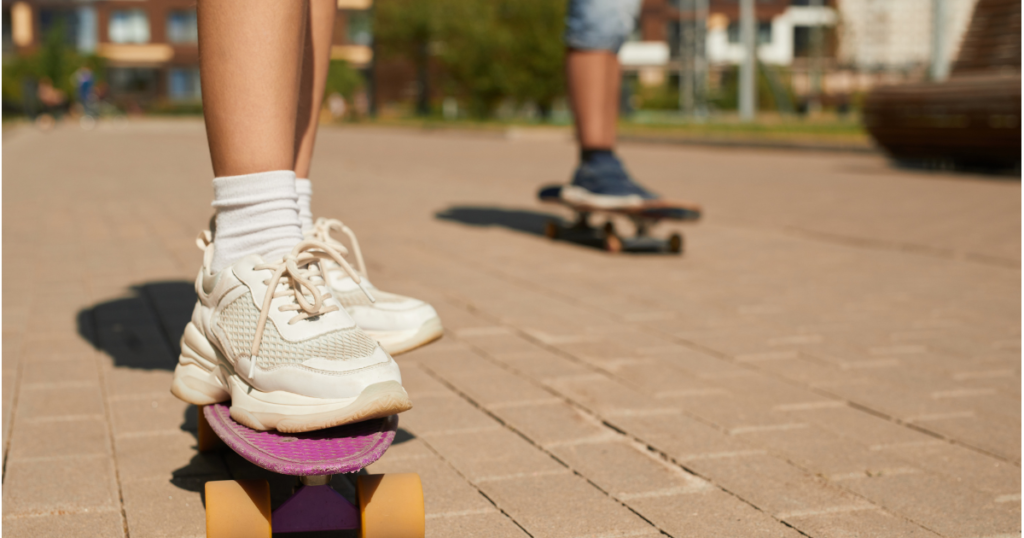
[561,152,658,209]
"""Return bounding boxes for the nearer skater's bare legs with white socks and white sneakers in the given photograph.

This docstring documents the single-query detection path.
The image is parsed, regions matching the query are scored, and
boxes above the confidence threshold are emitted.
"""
[171,0,442,431]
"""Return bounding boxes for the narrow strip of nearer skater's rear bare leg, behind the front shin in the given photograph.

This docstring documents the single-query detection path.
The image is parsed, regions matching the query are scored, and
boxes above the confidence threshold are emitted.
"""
[295,0,338,178]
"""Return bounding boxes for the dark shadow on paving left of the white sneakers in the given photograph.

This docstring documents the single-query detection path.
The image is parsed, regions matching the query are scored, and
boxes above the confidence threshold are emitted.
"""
[78,281,196,370]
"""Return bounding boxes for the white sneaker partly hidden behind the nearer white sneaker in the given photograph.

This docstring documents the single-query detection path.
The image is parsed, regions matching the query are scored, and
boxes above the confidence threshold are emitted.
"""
[306,218,444,355]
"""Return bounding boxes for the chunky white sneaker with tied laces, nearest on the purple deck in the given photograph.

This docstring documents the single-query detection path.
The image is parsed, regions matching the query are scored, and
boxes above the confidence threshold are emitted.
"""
[171,232,413,431]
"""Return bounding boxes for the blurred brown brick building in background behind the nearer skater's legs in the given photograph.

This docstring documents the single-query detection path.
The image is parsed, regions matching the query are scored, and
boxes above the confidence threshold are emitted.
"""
[2,0,373,104]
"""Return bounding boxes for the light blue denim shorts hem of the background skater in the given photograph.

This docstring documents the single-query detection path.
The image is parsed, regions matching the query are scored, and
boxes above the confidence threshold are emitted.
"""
[565,0,642,52]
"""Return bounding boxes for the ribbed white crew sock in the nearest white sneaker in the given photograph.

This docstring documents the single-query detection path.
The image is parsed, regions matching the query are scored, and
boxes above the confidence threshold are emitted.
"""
[210,170,302,273]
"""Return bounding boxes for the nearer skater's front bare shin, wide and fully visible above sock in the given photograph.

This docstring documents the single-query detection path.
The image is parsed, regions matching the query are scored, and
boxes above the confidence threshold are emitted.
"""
[198,0,308,177]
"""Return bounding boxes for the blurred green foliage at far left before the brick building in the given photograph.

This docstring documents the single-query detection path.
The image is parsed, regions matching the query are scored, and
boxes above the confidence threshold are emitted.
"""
[3,22,106,105]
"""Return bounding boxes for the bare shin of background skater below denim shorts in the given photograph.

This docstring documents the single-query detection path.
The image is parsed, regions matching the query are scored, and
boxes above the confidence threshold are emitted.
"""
[565,49,620,150]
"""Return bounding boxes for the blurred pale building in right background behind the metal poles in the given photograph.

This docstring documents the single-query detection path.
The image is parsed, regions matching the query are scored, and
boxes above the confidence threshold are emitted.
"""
[620,0,977,106]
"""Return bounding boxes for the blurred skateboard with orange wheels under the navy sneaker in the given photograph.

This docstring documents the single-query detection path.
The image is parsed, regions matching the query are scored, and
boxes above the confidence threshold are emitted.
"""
[538,185,701,254]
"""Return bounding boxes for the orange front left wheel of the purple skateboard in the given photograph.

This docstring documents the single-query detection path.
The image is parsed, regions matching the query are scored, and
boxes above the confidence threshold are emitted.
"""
[206,480,272,538]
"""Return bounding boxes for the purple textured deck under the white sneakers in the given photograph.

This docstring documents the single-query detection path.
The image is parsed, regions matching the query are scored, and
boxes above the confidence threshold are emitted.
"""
[203,404,398,477]
